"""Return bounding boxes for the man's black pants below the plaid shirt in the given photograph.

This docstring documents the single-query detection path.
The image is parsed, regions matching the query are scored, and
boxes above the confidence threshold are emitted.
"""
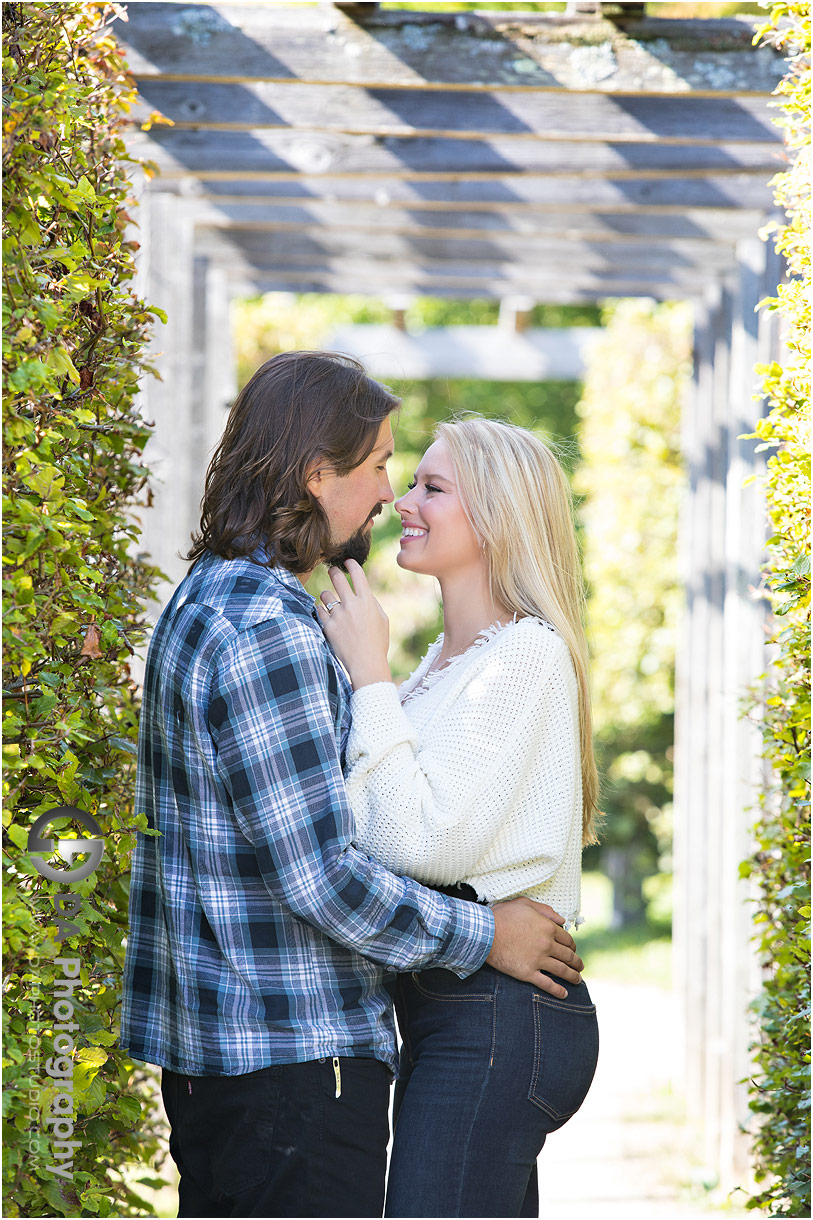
[161,1057,389,1218]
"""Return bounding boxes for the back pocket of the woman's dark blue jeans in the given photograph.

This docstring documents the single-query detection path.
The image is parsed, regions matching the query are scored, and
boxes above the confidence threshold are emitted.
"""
[527,983,598,1131]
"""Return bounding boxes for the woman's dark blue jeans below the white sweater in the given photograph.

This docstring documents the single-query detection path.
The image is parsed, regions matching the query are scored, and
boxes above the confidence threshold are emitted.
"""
[386,966,598,1216]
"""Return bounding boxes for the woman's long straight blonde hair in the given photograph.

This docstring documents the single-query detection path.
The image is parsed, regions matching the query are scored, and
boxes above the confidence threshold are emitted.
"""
[435,416,601,844]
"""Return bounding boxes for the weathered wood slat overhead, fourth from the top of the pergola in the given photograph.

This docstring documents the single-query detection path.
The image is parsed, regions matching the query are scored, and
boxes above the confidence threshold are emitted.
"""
[177,172,773,214]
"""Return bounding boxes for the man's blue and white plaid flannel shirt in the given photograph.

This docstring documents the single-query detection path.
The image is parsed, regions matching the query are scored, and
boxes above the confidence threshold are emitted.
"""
[121,555,493,1076]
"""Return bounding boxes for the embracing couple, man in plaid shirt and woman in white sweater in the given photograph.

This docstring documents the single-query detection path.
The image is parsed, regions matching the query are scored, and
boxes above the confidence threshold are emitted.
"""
[121,351,598,1218]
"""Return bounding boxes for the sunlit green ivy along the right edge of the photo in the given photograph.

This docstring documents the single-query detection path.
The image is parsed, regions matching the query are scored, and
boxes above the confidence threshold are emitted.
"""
[741,0,811,1216]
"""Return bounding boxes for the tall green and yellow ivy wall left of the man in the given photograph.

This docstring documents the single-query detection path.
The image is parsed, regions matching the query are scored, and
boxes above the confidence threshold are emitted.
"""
[2,2,167,1216]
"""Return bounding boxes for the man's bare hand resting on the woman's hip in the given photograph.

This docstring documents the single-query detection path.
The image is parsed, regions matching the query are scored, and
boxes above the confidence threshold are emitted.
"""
[486,898,585,999]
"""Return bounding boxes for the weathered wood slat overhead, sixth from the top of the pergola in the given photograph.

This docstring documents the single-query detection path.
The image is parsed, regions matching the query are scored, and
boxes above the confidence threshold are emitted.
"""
[195,227,731,272]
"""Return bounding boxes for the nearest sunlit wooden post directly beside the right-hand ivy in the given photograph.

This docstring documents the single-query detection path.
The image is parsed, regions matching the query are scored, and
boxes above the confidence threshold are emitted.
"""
[718,238,780,1190]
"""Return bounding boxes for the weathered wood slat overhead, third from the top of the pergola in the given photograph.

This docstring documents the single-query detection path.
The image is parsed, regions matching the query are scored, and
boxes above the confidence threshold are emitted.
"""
[131,128,785,179]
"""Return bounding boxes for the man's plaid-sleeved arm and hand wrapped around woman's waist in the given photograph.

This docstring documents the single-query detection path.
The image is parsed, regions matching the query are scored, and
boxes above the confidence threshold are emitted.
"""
[209,620,580,991]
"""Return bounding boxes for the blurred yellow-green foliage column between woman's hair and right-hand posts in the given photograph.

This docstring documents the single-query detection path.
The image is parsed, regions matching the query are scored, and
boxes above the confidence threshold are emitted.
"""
[575,300,691,925]
